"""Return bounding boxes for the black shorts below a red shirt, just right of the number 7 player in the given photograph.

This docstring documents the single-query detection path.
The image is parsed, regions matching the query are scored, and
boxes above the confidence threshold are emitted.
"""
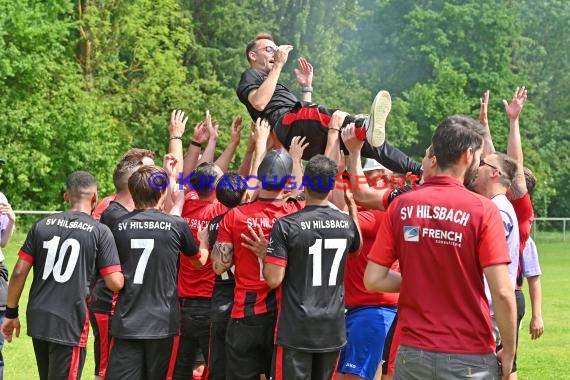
[173,298,212,380]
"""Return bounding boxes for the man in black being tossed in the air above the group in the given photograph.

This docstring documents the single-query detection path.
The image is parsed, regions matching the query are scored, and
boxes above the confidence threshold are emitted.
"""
[237,33,421,175]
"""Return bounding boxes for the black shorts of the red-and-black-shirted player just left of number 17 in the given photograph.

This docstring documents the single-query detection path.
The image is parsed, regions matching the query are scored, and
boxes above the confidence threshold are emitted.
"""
[226,313,277,380]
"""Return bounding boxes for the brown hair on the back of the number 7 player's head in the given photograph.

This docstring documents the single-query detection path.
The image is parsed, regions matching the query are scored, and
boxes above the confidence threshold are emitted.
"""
[128,165,164,209]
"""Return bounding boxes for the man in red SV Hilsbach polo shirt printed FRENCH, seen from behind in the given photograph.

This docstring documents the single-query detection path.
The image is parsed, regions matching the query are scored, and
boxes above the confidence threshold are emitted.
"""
[364,116,516,379]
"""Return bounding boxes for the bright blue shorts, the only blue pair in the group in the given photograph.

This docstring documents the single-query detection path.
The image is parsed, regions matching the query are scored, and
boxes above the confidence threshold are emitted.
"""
[337,306,396,380]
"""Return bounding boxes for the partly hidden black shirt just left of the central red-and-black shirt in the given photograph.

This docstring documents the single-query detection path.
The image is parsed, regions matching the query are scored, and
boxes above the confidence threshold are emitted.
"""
[208,213,236,320]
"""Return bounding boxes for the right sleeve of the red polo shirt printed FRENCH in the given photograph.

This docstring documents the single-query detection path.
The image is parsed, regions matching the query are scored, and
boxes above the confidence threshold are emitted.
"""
[478,201,511,268]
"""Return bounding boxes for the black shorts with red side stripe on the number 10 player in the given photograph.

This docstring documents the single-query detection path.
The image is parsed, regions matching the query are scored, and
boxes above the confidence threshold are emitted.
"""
[32,338,86,380]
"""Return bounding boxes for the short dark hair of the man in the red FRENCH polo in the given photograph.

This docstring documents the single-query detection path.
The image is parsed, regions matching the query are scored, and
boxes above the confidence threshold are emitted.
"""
[431,115,485,169]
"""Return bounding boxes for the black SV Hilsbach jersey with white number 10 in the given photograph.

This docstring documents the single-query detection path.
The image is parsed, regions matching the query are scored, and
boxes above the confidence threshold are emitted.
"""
[19,211,121,347]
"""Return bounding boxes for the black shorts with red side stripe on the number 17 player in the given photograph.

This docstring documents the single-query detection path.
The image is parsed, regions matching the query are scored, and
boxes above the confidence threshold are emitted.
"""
[271,346,340,380]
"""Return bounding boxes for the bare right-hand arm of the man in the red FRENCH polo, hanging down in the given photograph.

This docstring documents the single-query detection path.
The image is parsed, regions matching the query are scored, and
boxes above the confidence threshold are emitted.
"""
[483,264,517,378]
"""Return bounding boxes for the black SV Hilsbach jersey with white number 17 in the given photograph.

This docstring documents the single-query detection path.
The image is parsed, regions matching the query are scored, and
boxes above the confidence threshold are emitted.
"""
[265,206,360,352]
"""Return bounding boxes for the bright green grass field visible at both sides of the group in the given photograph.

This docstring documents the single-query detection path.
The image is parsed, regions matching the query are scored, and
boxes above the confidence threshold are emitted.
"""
[3,233,570,380]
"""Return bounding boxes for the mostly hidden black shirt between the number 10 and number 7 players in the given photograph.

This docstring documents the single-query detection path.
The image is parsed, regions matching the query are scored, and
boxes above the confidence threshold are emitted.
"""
[89,201,129,314]
